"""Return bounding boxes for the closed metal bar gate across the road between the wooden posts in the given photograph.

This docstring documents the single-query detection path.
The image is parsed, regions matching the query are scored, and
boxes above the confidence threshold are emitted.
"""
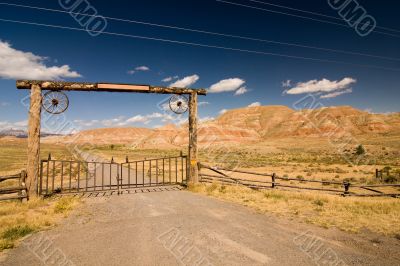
[38,156,188,195]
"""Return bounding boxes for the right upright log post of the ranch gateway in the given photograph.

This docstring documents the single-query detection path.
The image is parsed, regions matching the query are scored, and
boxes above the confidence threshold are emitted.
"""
[188,92,199,184]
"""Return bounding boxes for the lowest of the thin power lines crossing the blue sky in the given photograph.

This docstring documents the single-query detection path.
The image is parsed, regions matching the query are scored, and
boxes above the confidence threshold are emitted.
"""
[0,18,400,71]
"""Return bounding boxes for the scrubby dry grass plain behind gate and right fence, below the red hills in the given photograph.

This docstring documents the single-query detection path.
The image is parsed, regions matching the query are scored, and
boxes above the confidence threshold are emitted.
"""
[83,136,400,184]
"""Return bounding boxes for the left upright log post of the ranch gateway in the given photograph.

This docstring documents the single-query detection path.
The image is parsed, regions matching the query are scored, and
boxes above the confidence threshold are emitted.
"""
[26,85,42,197]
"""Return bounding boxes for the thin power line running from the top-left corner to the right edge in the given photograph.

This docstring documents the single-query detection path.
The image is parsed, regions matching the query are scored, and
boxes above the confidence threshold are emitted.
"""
[0,2,400,61]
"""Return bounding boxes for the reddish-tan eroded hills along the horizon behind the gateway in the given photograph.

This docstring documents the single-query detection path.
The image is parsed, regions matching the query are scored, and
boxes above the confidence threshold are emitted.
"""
[39,106,400,148]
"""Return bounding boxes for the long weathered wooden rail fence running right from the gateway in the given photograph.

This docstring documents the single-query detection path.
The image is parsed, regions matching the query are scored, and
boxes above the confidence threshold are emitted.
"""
[199,163,400,197]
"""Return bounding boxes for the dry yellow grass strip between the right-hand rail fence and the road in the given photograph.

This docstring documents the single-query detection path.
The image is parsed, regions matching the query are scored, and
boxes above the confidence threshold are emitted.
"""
[189,184,400,236]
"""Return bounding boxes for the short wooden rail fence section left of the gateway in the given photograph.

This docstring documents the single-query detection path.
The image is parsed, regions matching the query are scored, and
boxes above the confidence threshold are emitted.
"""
[0,171,28,201]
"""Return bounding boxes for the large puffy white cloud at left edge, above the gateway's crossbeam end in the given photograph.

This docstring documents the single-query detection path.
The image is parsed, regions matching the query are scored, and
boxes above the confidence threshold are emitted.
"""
[0,40,81,80]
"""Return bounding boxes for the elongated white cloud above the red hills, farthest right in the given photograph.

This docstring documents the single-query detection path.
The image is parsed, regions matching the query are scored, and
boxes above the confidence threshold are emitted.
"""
[286,78,357,94]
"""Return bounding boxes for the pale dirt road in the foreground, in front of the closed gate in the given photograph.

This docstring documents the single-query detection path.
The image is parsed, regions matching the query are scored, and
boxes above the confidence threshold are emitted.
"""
[0,188,400,265]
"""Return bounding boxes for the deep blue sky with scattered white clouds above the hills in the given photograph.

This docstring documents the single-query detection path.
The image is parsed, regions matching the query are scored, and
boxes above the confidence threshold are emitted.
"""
[0,0,400,131]
